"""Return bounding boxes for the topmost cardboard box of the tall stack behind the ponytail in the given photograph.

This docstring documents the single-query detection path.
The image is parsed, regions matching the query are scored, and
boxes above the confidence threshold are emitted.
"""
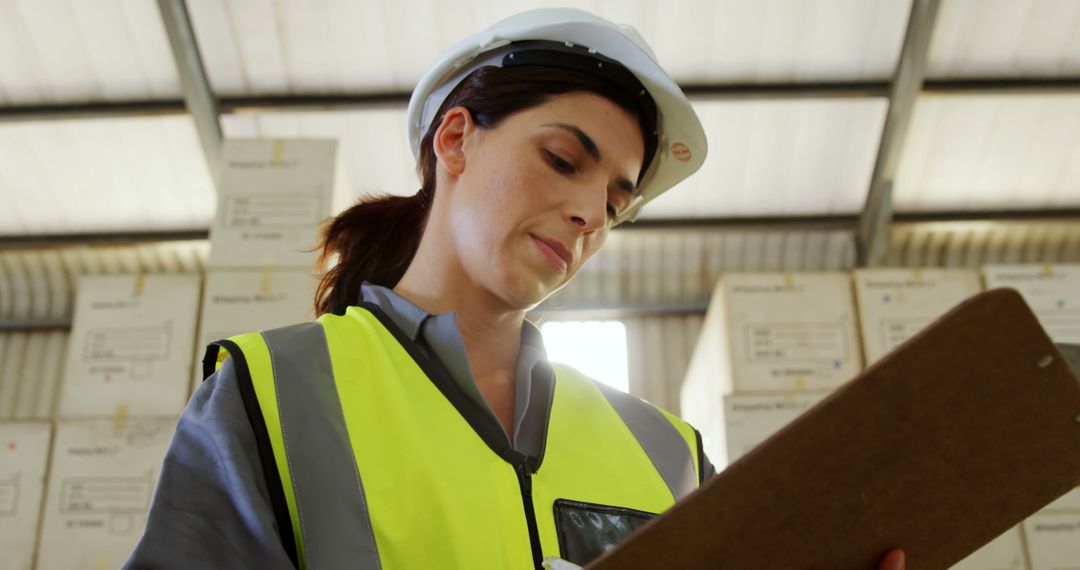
[208,139,351,269]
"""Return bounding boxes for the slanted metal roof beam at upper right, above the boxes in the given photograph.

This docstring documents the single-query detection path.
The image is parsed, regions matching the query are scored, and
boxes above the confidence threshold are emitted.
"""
[855,0,941,267]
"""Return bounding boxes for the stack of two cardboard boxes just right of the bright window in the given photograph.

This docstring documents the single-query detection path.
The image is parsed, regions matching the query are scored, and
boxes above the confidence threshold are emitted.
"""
[681,273,862,469]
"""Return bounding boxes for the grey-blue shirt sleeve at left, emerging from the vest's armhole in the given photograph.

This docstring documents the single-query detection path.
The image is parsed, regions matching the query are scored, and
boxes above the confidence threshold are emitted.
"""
[123,359,295,570]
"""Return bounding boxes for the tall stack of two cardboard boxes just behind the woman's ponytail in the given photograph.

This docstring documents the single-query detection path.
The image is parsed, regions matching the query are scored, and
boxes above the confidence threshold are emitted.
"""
[193,139,349,388]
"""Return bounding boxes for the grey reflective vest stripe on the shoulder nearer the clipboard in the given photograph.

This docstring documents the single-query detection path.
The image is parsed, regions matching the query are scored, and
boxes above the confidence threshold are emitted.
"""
[595,382,698,501]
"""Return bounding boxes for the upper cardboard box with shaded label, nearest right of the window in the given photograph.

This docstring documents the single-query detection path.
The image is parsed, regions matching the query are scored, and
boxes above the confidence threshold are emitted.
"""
[681,273,862,414]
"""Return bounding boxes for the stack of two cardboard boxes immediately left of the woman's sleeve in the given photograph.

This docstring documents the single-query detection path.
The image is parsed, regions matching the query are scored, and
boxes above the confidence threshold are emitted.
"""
[37,274,200,570]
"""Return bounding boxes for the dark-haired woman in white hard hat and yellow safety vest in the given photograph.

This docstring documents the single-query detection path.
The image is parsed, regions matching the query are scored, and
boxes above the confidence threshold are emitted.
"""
[129,10,902,569]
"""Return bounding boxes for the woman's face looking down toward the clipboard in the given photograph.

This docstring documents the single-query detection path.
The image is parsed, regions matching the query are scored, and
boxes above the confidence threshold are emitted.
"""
[440,92,645,309]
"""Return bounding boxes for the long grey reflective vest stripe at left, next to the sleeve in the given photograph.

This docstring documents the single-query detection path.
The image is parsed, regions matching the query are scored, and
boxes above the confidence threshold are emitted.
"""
[262,322,380,570]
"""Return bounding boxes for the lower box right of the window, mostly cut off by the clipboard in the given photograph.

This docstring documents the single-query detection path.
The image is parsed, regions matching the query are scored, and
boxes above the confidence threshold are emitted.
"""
[710,392,828,463]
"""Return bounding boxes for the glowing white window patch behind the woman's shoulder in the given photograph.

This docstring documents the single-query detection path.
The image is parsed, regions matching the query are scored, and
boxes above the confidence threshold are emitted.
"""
[540,321,630,392]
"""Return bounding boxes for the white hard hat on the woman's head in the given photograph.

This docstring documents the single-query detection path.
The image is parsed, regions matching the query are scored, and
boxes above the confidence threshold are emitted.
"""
[406,8,707,222]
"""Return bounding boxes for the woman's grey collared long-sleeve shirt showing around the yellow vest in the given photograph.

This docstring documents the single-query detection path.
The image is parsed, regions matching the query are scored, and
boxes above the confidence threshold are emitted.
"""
[124,284,715,570]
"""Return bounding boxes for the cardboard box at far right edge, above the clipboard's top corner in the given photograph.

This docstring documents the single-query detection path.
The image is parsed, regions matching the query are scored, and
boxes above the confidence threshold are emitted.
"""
[983,264,1080,343]
